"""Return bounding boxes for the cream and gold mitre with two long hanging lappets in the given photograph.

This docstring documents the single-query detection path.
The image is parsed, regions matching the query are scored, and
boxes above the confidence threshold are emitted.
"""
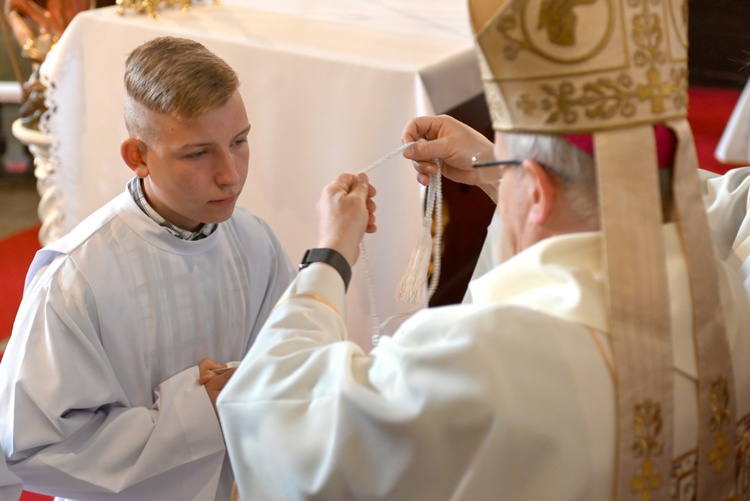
[469,0,736,494]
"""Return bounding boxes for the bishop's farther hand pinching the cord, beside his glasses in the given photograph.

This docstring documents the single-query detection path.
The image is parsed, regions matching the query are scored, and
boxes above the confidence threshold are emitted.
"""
[401,115,494,189]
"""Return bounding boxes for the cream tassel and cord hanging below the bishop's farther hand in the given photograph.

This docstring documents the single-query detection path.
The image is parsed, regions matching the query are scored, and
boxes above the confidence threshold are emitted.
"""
[396,164,442,305]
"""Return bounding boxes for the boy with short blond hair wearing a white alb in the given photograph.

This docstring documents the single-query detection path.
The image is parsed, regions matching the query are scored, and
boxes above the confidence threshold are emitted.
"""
[0,37,294,500]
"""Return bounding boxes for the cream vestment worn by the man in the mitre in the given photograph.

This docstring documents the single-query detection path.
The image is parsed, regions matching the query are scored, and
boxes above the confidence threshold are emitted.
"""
[218,225,750,501]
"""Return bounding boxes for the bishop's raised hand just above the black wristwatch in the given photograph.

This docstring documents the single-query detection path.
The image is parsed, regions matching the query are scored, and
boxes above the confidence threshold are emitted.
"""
[318,173,377,266]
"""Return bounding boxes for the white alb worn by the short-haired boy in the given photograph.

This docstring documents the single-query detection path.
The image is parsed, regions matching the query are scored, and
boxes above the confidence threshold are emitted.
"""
[0,192,295,501]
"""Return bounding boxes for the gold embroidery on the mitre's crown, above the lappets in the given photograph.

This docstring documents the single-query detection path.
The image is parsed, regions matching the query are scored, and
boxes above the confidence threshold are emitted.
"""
[495,0,688,125]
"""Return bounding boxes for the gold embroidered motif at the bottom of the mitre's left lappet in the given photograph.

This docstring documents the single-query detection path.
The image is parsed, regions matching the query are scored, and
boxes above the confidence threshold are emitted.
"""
[630,400,664,501]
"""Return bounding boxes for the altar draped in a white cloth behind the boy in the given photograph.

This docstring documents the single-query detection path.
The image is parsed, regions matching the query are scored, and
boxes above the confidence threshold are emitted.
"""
[36,0,482,348]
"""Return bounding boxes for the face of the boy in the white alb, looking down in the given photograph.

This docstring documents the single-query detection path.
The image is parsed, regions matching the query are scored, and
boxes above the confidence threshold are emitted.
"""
[136,91,250,230]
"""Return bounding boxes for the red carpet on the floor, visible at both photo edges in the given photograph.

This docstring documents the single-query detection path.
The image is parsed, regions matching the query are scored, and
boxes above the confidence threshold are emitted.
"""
[0,87,741,501]
